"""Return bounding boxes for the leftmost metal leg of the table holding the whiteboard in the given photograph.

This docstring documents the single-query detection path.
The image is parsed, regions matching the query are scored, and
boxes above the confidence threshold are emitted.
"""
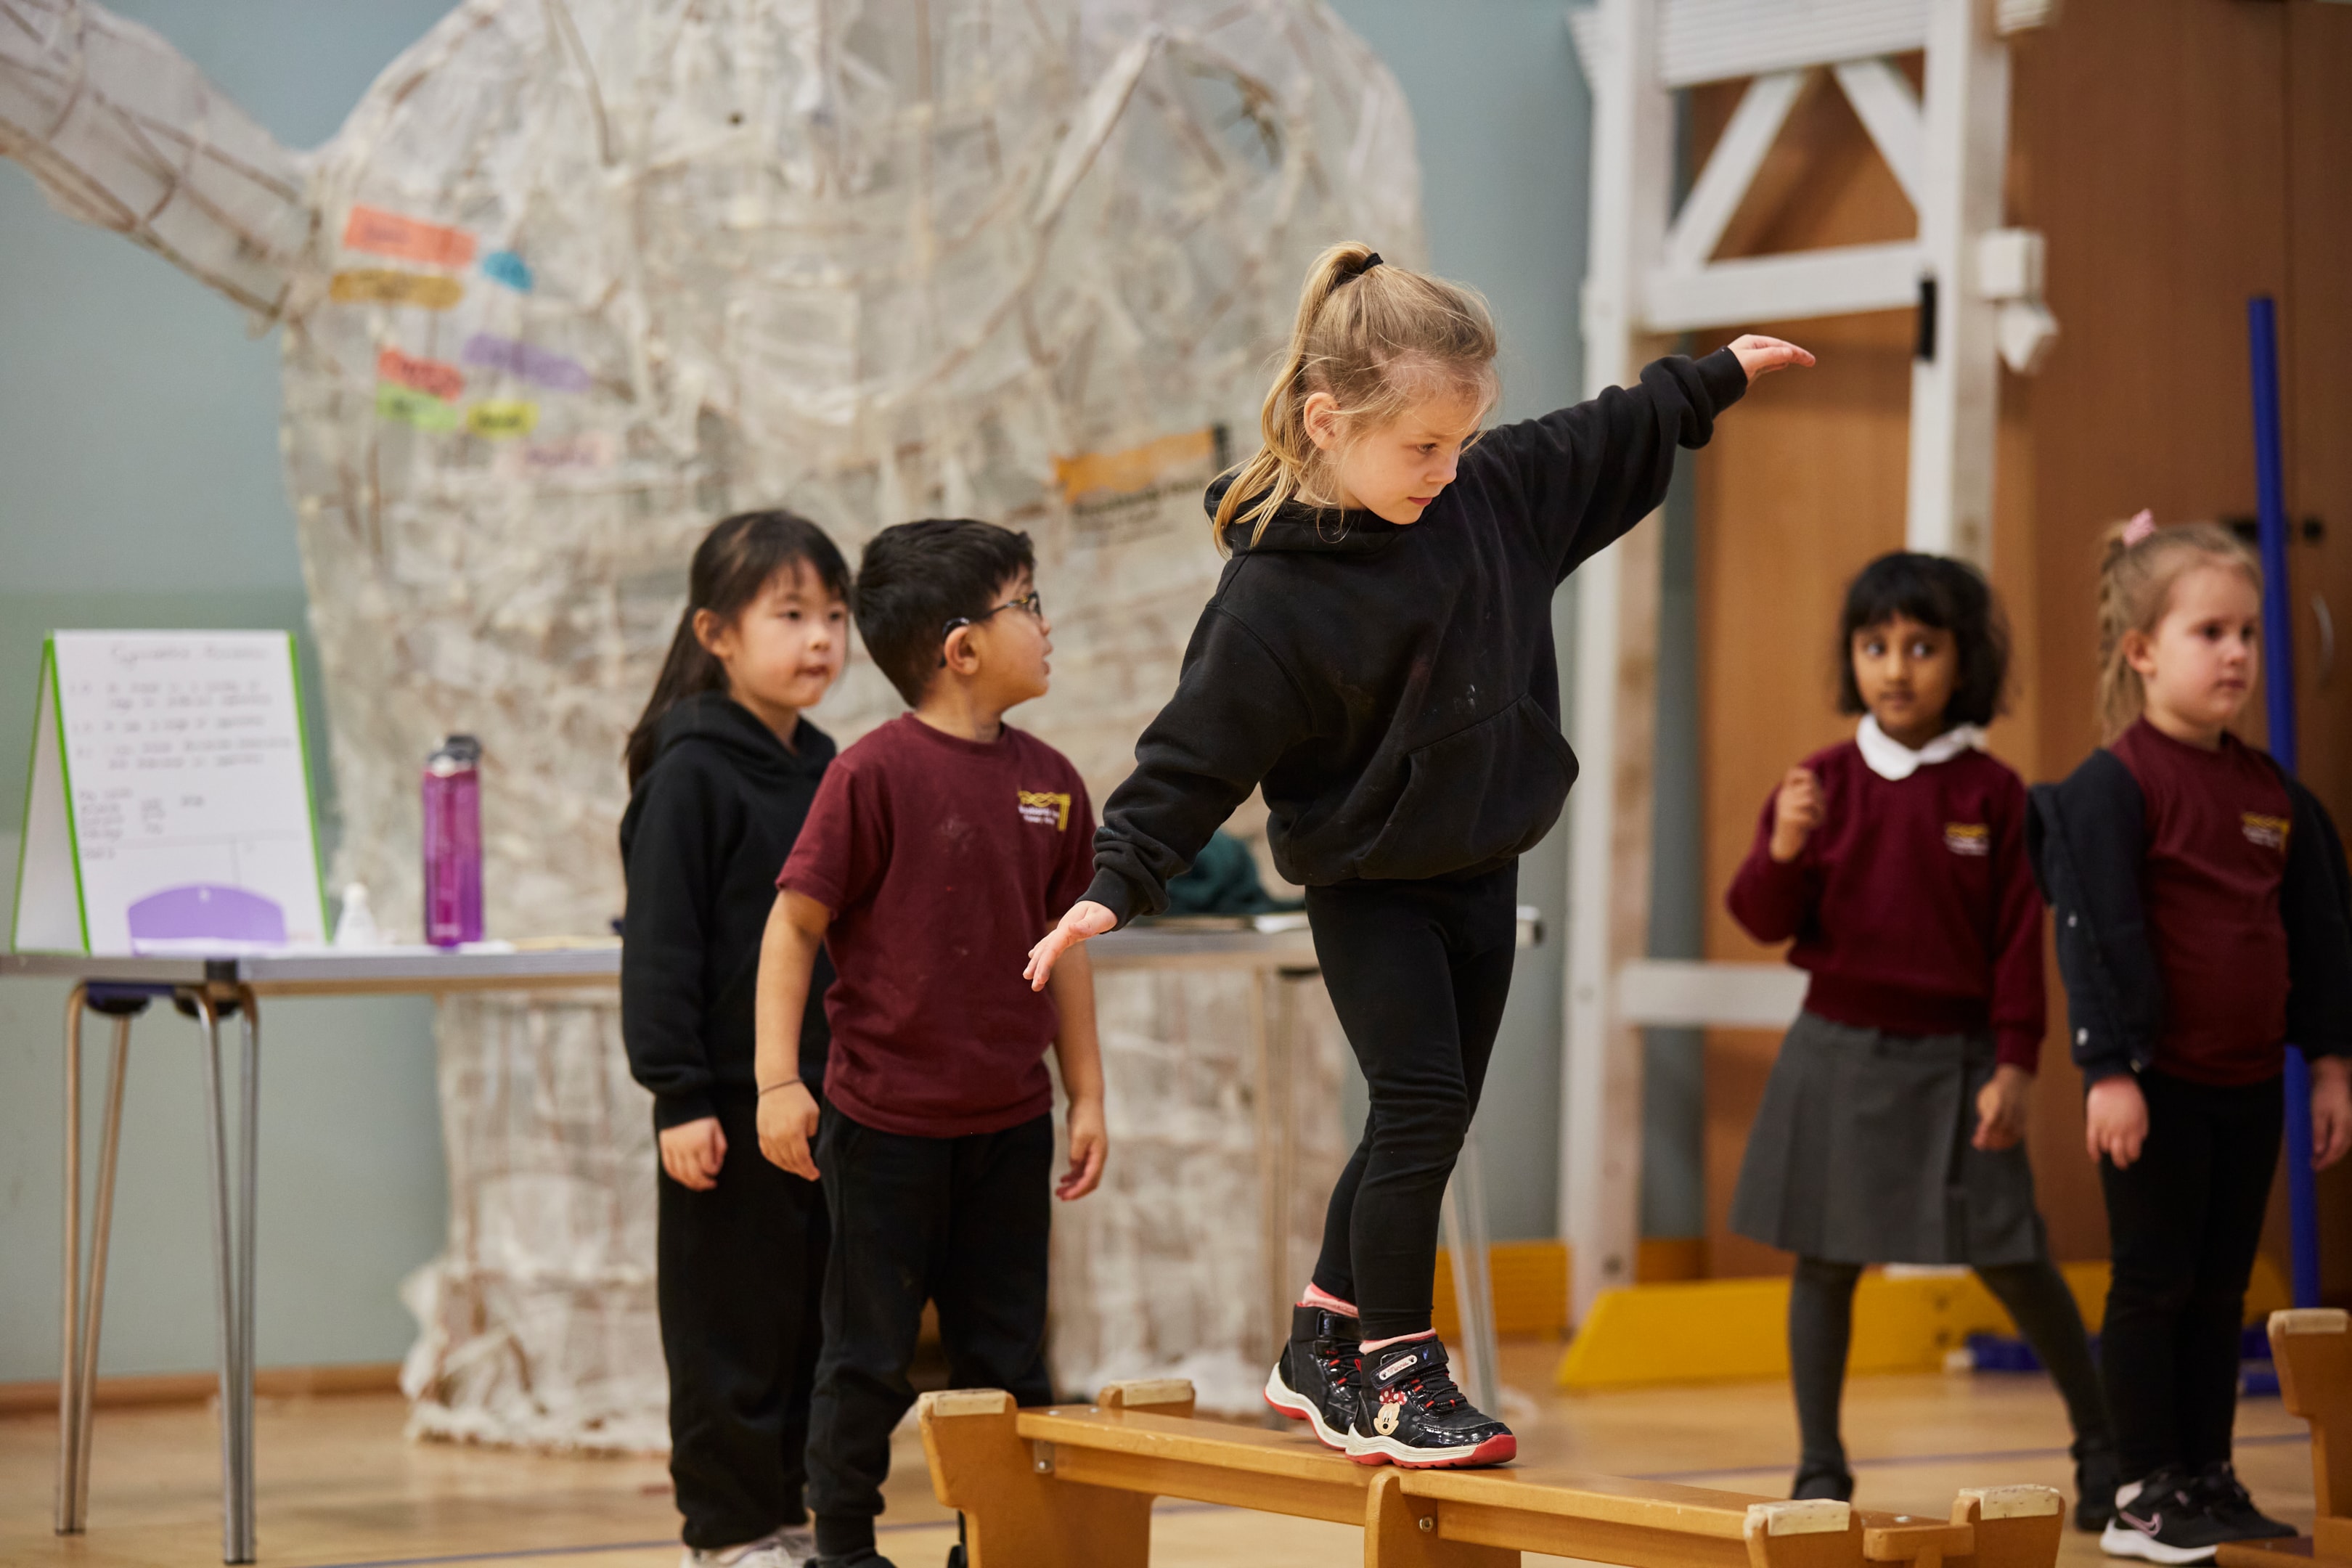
[57,985,146,1535]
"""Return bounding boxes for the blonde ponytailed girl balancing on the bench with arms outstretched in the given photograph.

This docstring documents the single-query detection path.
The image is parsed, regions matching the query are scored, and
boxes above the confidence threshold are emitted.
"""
[1028,245,1813,1467]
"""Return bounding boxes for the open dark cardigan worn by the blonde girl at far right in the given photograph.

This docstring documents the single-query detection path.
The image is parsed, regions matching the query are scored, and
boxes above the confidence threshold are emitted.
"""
[2025,748,2352,1084]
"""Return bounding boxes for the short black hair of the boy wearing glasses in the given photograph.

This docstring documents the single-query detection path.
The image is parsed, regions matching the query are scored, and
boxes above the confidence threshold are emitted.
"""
[859,517,1037,708]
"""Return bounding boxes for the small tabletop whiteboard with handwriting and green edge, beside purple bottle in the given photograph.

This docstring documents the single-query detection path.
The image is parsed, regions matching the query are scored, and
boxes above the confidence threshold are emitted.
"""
[12,632,327,955]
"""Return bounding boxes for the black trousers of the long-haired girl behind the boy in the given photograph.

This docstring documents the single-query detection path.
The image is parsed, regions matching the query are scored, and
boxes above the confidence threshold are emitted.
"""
[656,1086,828,1551]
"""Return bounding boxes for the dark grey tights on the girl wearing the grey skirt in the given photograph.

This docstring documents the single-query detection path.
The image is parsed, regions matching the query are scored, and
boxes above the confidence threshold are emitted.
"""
[1787,1255,2112,1477]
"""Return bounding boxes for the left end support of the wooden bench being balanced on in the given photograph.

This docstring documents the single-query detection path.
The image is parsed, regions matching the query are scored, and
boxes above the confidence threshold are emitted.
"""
[918,1389,1153,1568]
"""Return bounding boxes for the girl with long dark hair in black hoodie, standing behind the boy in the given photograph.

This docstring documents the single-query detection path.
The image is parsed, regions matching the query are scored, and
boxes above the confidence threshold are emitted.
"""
[621,513,849,1568]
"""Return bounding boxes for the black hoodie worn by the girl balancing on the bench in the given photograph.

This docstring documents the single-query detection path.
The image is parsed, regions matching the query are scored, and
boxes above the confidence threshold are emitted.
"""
[1087,351,1747,924]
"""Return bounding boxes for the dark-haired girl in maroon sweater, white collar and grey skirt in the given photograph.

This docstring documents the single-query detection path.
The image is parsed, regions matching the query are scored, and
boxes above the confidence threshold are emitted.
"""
[1731,552,2117,1530]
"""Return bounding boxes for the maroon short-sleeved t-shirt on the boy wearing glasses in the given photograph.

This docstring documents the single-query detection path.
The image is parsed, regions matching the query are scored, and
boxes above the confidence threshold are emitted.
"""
[776,714,1094,1138]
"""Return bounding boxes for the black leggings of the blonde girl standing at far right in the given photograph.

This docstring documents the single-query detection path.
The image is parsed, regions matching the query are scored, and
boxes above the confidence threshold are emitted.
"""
[2098,1072,2286,1481]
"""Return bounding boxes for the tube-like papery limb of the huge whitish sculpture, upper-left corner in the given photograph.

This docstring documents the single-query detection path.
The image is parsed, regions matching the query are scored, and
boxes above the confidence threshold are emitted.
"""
[0,0,313,322]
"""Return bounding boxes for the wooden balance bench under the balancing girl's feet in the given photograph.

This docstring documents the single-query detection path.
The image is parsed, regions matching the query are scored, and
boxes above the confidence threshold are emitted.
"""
[920,1380,2060,1568]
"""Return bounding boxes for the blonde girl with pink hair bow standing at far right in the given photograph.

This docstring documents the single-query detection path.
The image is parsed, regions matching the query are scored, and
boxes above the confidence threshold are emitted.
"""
[2032,513,2352,1564]
